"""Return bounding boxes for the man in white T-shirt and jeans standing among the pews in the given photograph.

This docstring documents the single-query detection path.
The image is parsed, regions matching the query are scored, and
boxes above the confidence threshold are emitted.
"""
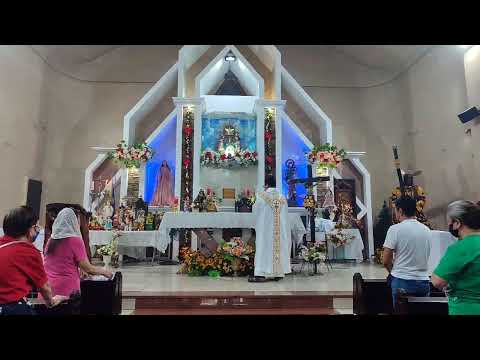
[383,196,431,306]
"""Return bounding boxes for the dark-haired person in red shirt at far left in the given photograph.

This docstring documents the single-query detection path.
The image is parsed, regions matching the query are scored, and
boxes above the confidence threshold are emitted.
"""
[0,206,65,315]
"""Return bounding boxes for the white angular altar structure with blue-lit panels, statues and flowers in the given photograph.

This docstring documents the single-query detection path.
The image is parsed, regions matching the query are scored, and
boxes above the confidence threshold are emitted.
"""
[84,45,373,264]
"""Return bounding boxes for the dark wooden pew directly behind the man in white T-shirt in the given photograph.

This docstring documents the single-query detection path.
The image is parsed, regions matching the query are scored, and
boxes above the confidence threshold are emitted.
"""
[395,290,448,315]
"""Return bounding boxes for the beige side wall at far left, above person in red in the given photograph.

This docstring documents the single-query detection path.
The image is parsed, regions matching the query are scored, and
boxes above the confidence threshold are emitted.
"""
[0,46,47,219]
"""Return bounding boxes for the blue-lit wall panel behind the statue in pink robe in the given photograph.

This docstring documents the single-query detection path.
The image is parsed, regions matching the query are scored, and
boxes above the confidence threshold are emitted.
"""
[144,116,177,203]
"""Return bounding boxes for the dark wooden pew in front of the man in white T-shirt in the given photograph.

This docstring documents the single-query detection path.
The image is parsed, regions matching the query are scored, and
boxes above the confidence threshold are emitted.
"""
[353,273,445,315]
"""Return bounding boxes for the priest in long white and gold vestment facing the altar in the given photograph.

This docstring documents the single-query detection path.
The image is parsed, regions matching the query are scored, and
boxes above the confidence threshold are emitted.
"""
[248,176,292,282]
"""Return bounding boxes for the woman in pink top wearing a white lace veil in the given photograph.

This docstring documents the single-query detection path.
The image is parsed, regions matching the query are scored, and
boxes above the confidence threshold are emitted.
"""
[45,208,113,296]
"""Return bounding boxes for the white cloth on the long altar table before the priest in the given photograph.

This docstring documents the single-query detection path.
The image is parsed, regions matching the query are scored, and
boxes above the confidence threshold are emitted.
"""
[158,212,306,251]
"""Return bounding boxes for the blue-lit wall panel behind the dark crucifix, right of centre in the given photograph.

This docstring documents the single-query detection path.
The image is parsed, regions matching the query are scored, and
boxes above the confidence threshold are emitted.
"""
[282,119,310,206]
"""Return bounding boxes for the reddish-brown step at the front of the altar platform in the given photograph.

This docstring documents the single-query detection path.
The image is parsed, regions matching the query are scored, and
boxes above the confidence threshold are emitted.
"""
[124,291,351,315]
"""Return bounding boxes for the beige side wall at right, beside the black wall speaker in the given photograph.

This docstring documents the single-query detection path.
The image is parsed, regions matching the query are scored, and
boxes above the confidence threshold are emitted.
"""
[398,46,472,227]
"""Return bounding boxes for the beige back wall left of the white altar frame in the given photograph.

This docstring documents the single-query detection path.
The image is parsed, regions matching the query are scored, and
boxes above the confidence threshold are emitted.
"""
[42,71,151,221]
